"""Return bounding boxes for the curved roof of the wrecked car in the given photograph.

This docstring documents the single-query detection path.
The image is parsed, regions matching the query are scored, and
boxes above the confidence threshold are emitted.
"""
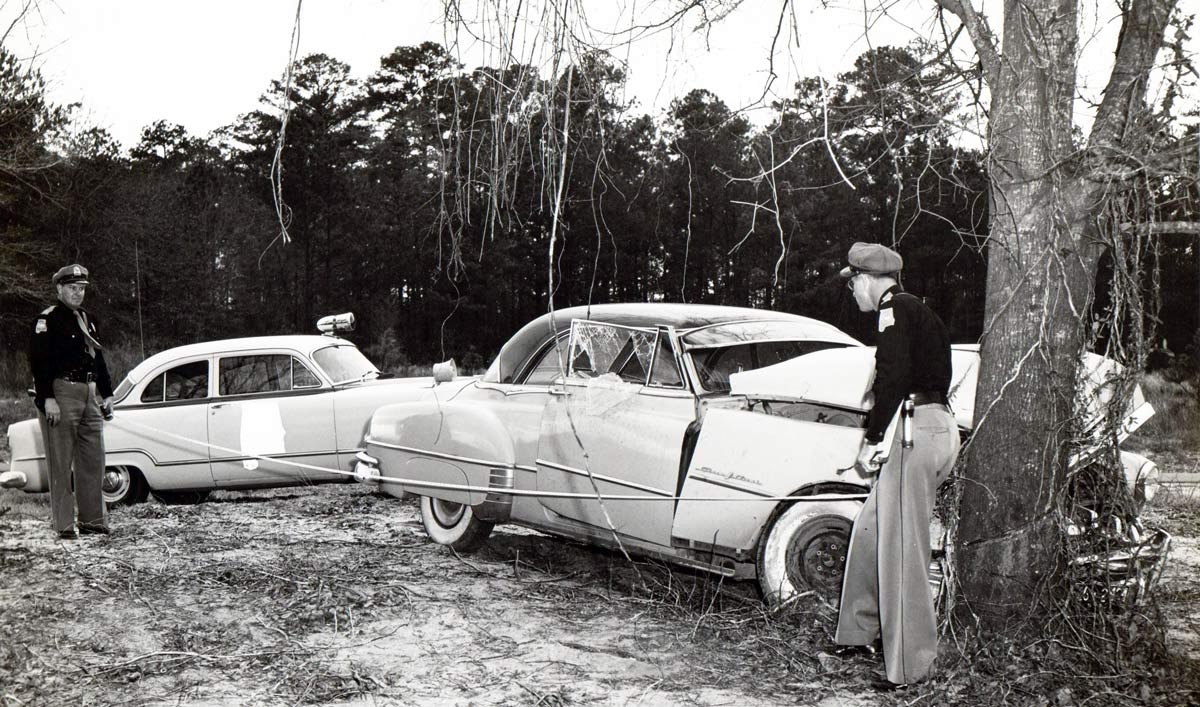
[488,302,847,381]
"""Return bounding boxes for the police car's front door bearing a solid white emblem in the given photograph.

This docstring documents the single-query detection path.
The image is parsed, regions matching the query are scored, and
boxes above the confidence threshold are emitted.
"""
[209,352,338,486]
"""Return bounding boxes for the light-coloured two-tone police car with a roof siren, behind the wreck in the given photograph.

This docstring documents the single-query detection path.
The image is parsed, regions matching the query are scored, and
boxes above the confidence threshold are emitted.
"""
[0,314,432,504]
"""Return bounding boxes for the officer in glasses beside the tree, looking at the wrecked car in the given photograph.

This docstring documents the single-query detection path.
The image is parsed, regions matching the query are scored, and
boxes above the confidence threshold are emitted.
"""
[835,242,959,690]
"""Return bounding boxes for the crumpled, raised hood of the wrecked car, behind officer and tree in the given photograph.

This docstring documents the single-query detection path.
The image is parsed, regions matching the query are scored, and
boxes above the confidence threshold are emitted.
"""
[730,344,1154,439]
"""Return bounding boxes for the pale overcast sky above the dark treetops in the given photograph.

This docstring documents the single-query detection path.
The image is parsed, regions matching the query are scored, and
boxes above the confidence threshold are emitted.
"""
[0,0,1176,148]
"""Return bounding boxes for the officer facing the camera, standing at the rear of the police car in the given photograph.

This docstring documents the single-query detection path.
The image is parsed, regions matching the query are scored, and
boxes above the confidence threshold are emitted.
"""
[29,265,113,539]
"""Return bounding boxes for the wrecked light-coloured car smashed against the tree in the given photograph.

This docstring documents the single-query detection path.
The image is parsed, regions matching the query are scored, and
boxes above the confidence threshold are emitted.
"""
[355,304,1153,603]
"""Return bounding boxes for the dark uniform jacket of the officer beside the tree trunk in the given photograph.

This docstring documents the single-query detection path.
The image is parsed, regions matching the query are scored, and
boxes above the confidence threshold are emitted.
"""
[866,284,950,444]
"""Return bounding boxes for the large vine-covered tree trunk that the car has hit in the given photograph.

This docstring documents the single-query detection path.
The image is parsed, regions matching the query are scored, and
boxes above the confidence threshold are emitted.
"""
[943,0,1174,628]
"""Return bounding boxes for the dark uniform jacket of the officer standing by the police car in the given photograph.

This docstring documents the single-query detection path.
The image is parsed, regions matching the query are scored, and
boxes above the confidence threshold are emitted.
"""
[29,304,113,411]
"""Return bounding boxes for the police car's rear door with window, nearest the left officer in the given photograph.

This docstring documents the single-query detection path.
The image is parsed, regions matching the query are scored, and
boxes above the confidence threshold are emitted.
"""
[104,358,212,489]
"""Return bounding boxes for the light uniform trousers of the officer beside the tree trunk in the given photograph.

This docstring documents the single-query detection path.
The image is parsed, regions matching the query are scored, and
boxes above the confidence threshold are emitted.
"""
[835,406,959,683]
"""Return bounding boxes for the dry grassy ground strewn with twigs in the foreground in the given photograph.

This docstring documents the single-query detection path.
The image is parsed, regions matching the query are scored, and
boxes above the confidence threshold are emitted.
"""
[0,485,1200,707]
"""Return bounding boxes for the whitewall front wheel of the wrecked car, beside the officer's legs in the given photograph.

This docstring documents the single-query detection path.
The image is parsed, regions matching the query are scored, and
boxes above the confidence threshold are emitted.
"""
[757,501,863,606]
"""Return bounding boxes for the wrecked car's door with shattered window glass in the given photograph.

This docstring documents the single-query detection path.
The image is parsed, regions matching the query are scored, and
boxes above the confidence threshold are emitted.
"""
[538,320,696,546]
